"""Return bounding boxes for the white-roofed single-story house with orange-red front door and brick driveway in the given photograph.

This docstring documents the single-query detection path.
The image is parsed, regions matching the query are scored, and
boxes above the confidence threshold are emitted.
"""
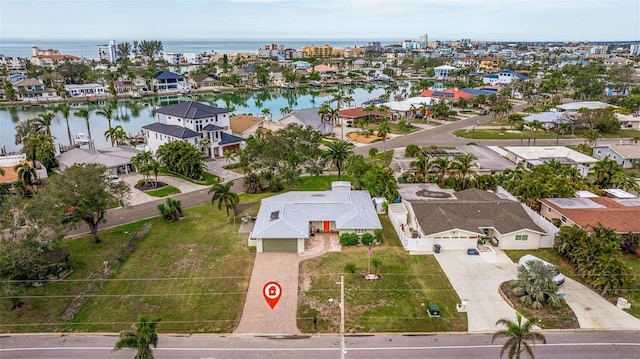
[249,182,382,253]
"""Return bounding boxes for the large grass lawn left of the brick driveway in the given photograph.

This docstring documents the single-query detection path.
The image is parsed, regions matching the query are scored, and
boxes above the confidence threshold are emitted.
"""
[0,205,255,333]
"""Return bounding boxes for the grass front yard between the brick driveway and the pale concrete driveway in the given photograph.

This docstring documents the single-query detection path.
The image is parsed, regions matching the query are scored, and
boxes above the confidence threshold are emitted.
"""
[298,217,467,333]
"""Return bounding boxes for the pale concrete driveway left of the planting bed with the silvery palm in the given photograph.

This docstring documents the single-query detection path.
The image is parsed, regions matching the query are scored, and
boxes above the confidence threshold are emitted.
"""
[435,249,518,332]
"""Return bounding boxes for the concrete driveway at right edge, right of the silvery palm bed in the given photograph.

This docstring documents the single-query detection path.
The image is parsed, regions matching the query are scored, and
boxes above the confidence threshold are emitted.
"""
[558,278,640,330]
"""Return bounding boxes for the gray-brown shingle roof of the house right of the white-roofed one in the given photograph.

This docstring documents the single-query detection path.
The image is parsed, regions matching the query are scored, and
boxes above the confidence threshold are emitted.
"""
[411,189,545,235]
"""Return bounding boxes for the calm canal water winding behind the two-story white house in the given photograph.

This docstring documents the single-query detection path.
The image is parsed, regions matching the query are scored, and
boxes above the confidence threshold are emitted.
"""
[0,83,398,152]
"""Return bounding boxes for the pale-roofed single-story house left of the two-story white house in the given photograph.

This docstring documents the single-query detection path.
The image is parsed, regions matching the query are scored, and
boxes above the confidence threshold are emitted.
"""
[56,146,140,175]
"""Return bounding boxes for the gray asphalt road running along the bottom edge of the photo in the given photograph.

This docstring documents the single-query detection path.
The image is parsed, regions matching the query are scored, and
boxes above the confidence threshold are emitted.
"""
[0,331,640,359]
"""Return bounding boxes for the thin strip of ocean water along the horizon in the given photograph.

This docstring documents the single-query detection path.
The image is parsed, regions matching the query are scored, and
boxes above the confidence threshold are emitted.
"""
[0,39,378,59]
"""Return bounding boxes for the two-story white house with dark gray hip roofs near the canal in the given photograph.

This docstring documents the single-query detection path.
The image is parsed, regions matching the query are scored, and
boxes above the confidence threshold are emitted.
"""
[142,101,245,157]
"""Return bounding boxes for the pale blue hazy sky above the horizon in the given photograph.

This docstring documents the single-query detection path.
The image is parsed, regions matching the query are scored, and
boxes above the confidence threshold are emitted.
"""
[0,0,640,41]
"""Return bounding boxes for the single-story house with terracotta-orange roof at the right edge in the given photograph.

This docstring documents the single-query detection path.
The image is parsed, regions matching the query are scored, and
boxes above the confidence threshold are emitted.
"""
[540,197,640,234]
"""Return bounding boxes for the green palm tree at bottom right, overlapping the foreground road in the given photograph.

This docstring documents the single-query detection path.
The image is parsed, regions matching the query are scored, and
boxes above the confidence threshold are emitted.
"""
[491,312,547,359]
